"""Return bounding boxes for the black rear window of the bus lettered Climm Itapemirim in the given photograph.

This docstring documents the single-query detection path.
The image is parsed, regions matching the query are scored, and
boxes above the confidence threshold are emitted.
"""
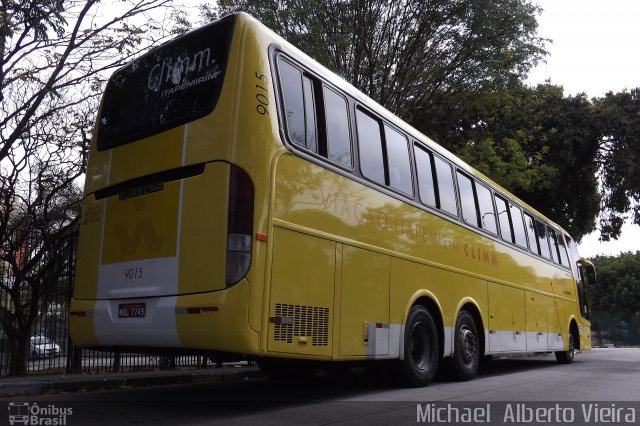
[97,17,234,151]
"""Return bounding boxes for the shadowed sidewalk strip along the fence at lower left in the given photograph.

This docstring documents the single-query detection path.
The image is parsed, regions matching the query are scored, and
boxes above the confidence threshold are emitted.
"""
[0,365,261,398]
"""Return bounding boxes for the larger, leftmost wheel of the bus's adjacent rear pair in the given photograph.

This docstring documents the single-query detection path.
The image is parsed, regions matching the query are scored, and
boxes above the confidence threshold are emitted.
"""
[401,305,440,387]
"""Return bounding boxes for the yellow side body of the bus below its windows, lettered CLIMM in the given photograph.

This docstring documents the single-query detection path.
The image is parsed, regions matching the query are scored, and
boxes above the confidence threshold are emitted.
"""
[270,151,575,359]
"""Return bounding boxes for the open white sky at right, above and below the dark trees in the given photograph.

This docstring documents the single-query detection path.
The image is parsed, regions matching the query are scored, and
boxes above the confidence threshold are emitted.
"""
[527,0,640,257]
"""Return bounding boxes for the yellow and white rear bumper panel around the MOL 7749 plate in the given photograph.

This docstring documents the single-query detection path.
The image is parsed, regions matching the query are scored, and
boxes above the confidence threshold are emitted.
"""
[69,281,258,353]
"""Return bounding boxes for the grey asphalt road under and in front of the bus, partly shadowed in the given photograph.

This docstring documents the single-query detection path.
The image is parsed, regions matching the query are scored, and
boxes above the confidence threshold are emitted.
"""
[5,349,640,426]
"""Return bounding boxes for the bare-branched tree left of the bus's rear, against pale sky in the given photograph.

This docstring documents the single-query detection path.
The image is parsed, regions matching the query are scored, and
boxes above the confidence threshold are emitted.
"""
[0,0,181,374]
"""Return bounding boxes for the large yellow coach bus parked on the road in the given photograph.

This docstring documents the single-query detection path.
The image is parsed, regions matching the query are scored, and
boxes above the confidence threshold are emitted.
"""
[70,13,593,386]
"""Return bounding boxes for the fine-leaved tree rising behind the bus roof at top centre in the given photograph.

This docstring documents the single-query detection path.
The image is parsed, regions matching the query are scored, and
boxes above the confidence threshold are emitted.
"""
[209,0,545,118]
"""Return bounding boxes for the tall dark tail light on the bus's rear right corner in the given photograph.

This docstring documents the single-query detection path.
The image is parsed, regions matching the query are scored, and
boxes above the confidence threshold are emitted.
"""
[227,165,253,286]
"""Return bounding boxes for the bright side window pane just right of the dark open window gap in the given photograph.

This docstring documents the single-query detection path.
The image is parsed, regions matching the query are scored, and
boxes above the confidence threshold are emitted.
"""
[323,86,352,167]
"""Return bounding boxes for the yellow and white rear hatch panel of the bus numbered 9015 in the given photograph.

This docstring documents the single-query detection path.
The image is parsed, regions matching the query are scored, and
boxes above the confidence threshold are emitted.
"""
[75,162,229,299]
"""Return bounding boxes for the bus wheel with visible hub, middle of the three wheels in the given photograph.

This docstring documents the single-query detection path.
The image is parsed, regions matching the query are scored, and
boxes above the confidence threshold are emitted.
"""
[453,311,480,380]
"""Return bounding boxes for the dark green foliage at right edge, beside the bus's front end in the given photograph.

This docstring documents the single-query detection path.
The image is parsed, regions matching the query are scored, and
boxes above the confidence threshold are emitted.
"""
[590,251,640,315]
